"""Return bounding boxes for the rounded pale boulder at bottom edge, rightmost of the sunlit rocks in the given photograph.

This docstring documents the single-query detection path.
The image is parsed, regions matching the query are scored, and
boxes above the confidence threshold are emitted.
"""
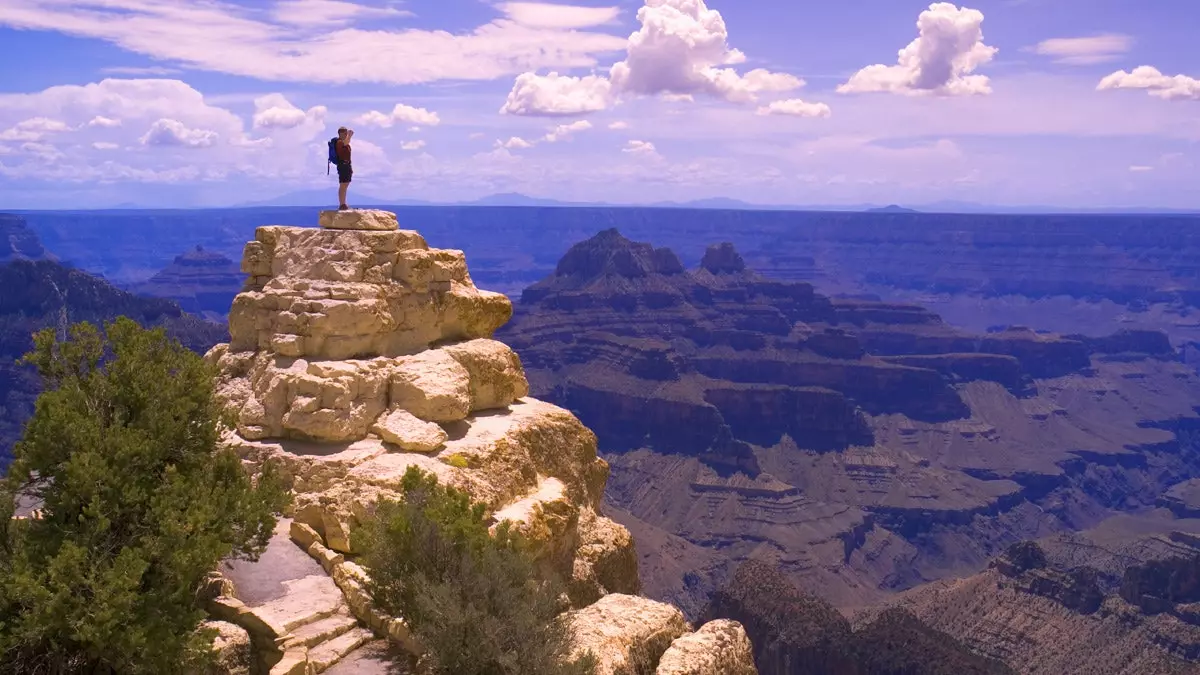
[655,619,758,675]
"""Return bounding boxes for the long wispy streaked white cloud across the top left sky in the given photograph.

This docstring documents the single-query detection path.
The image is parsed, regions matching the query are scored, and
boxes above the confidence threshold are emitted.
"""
[0,0,624,85]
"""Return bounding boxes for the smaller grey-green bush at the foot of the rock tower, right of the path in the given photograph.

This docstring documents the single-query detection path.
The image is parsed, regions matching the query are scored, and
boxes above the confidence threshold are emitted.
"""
[361,467,594,675]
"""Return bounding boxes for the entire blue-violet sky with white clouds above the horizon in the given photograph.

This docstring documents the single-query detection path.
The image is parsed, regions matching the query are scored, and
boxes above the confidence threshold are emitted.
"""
[0,0,1200,209]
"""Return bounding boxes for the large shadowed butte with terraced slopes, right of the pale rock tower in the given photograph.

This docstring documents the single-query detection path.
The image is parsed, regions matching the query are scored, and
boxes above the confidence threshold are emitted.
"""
[498,231,1200,614]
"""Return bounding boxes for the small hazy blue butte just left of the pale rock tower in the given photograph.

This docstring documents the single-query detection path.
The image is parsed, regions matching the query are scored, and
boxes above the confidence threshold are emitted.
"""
[130,246,246,317]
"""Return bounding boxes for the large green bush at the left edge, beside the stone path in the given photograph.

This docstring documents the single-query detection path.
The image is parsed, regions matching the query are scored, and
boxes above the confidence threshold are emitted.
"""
[0,317,287,674]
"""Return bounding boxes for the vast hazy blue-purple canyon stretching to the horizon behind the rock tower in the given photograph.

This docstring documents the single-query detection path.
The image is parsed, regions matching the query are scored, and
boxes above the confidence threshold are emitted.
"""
[7,207,1200,673]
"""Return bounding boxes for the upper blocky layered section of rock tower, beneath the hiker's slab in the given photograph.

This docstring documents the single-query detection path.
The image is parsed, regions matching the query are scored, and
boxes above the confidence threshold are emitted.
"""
[229,220,512,360]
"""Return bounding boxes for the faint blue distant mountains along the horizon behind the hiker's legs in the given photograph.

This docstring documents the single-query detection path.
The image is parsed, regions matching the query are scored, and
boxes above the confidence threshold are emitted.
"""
[226,190,1200,214]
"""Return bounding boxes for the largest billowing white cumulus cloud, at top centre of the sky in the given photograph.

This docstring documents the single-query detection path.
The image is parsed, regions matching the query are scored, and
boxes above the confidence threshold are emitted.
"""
[500,0,804,115]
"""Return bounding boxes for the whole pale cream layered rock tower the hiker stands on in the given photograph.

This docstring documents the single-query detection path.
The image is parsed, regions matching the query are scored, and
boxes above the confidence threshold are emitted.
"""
[206,211,748,673]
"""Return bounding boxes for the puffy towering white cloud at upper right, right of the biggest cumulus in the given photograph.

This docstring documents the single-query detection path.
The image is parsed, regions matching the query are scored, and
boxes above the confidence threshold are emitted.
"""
[838,2,998,96]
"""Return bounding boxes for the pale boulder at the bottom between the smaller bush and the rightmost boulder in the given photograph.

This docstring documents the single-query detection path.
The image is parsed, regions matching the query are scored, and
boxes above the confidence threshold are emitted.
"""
[565,593,690,675]
